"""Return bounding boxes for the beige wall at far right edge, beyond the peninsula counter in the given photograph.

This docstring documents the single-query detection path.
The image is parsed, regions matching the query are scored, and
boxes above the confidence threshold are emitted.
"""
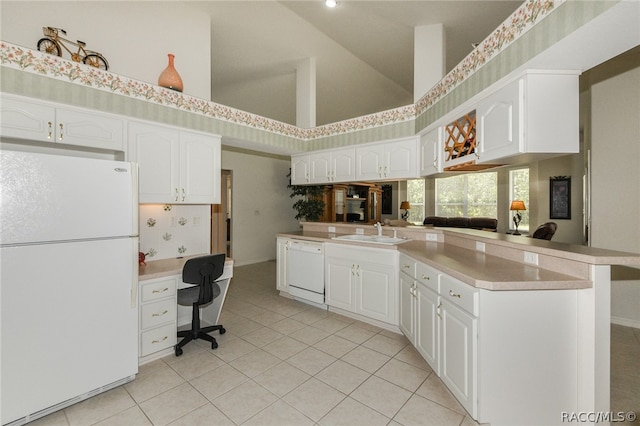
[591,53,640,328]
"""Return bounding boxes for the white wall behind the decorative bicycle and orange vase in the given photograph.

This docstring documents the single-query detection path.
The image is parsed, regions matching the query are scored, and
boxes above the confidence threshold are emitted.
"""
[0,0,211,100]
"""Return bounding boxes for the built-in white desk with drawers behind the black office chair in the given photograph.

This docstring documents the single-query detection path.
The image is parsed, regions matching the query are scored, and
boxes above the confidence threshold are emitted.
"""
[138,256,233,365]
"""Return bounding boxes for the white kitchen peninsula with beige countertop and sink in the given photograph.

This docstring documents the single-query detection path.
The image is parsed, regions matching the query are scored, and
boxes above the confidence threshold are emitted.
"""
[278,222,640,425]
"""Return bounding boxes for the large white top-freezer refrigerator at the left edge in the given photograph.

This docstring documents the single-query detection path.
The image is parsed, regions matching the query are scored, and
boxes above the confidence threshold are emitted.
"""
[0,150,138,425]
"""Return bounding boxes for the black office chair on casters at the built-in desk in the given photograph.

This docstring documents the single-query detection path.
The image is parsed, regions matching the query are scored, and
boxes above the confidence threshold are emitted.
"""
[175,253,227,356]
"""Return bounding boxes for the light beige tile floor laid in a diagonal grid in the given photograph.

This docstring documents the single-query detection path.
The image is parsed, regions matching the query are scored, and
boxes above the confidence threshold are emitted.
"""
[32,262,640,426]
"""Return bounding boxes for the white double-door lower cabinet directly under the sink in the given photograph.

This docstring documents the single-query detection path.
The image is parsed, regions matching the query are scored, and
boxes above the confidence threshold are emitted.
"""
[325,243,399,326]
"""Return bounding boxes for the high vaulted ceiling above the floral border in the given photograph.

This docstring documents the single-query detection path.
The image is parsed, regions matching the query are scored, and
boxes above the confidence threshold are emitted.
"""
[188,0,522,125]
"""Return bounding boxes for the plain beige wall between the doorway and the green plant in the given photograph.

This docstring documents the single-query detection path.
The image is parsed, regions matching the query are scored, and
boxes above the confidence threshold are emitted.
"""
[222,149,300,265]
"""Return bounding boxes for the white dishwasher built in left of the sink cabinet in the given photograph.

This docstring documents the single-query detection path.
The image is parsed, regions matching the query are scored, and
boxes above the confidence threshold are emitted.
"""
[287,240,324,304]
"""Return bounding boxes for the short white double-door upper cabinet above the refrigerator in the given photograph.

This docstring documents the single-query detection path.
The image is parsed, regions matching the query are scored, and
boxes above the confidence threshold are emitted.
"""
[0,94,125,151]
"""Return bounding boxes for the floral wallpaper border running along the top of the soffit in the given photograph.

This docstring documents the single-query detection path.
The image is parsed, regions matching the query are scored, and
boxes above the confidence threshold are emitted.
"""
[0,0,566,141]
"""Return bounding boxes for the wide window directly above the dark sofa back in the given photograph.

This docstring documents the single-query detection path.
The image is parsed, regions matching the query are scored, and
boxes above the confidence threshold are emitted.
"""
[436,172,498,218]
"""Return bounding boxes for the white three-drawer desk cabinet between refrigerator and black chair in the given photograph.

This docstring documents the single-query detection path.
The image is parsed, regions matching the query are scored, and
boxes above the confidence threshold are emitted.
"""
[138,275,180,358]
